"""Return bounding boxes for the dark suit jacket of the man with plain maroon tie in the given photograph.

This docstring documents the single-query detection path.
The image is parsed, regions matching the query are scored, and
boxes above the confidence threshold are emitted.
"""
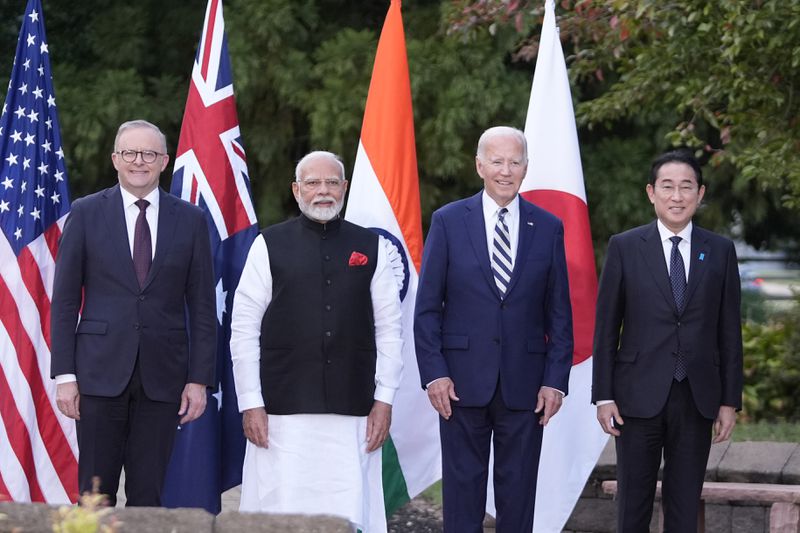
[50,185,217,402]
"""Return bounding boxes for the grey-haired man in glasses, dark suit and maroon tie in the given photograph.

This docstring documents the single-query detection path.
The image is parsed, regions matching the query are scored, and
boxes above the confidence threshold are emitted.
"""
[51,120,216,506]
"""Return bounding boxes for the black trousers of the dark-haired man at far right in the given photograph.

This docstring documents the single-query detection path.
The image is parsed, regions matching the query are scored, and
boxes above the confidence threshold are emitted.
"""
[616,379,713,533]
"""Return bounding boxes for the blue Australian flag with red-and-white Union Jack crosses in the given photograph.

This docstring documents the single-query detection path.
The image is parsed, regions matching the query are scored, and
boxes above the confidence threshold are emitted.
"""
[162,0,258,513]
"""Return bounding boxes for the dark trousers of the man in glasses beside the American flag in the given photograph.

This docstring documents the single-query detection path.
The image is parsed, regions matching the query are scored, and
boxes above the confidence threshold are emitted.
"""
[77,362,180,507]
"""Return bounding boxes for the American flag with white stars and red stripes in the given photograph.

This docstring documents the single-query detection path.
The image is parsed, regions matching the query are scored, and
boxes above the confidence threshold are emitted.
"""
[0,0,78,503]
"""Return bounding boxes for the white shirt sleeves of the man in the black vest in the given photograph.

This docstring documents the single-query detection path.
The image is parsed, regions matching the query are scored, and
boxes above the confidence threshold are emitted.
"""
[231,231,403,411]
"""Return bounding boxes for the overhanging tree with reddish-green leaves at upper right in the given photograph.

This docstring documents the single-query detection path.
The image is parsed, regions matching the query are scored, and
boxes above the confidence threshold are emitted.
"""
[446,0,800,256]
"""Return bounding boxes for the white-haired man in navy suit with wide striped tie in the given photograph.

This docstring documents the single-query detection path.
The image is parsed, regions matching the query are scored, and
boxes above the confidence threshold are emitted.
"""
[414,127,573,533]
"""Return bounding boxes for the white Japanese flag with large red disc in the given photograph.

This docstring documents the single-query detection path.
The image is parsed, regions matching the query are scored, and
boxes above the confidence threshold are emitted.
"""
[520,0,608,533]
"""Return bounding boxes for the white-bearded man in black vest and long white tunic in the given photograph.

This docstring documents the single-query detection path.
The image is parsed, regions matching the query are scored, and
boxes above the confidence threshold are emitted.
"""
[231,152,403,533]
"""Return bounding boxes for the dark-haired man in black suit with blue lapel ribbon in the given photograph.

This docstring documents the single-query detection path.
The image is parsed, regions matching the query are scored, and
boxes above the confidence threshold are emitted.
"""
[592,151,742,533]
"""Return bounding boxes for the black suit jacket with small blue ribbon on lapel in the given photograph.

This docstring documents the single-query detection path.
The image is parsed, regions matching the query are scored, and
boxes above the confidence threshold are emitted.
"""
[592,221,742,419]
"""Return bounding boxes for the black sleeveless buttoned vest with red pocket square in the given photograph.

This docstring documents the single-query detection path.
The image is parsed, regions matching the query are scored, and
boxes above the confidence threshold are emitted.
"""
[261,215,378,416]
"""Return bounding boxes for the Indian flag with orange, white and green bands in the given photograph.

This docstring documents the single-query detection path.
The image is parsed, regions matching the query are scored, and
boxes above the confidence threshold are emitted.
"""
[345,0,442,533]
